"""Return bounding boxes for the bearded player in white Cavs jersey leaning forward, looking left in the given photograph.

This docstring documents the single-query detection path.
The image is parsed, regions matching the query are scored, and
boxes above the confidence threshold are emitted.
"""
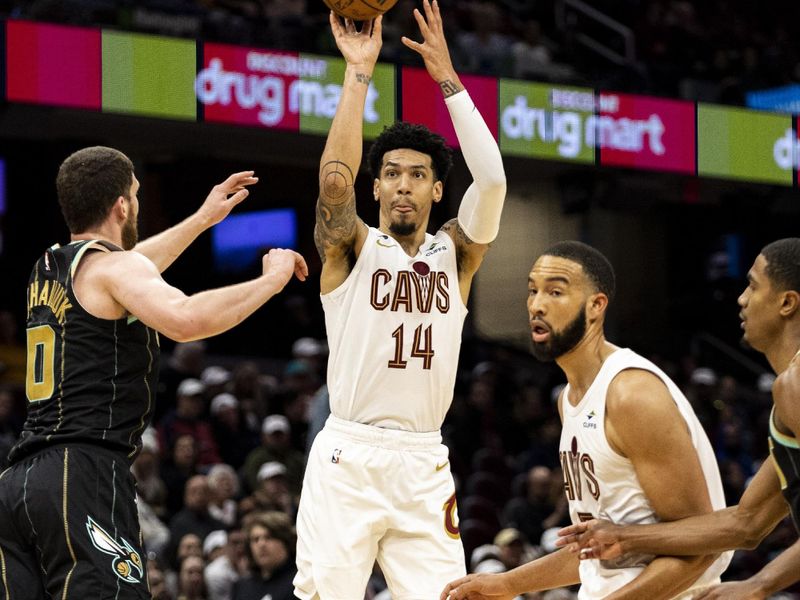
[441,241,730,600]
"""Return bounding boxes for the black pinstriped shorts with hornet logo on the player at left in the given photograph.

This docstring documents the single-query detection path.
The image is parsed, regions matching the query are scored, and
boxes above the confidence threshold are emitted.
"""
[0,444,150,600]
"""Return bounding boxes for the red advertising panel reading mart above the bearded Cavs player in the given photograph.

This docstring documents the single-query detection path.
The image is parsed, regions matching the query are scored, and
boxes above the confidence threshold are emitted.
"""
[594,92,697,174]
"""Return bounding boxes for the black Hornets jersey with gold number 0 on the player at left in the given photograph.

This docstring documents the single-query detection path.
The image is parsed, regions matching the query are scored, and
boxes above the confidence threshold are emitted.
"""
[9,240,159,463]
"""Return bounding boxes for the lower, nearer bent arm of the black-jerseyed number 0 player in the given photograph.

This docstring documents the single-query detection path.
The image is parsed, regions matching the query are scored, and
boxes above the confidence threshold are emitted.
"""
[98,249,308,342]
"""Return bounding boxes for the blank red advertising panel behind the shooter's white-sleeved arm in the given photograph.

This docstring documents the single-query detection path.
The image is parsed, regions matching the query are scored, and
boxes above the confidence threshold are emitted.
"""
[402,67,497,148]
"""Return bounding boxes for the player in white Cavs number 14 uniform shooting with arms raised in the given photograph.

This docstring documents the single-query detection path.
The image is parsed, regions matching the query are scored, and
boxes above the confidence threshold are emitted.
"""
[295,0,506,600]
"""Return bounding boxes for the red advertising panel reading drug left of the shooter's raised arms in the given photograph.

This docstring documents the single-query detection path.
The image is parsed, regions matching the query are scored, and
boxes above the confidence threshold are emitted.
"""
[195,44,303,131]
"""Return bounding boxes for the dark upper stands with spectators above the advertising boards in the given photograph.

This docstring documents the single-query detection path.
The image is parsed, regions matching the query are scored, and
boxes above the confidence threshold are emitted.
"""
[0,0,800,105]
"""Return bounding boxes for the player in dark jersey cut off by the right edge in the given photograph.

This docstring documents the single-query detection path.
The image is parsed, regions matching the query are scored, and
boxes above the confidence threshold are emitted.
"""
[559,238,800,600]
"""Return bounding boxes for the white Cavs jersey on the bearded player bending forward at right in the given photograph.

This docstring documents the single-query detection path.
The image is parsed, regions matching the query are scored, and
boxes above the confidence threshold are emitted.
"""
[559,349,732,600]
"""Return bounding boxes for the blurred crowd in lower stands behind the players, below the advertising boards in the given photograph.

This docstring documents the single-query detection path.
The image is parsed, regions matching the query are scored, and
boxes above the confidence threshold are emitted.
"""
[0,304,800,600]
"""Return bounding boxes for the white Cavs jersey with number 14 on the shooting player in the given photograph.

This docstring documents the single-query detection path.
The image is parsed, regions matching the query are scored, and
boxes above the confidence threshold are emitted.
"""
[321,227,467,432]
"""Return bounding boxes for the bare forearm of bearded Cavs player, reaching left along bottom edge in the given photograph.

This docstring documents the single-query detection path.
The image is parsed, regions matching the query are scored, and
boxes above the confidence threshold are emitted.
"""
[440,550,580,600]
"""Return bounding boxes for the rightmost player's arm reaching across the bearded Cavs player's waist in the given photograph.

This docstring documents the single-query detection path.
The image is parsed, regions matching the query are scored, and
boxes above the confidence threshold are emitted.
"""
[556,458,788,560]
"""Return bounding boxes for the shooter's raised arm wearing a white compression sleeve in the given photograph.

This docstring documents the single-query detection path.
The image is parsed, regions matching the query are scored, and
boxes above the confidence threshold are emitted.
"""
[403,0,506,288]
